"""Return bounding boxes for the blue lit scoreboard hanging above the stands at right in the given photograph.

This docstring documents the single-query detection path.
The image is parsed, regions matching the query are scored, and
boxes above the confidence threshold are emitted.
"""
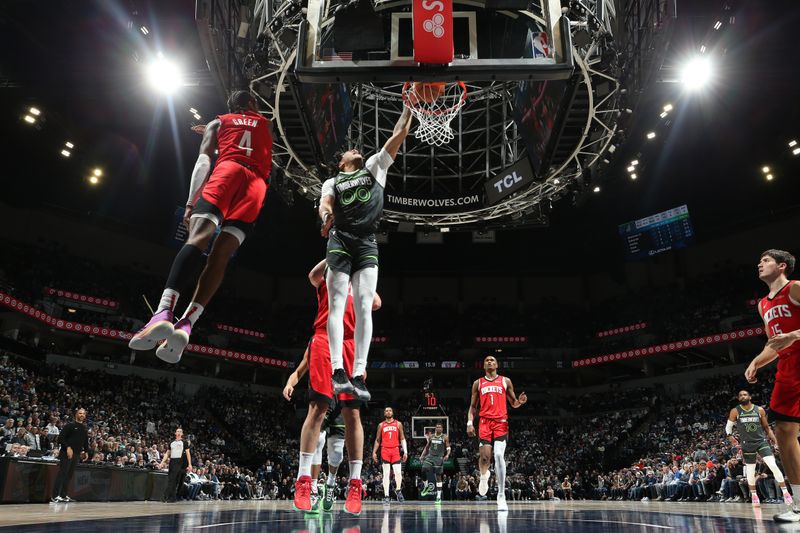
[619,205,694,259]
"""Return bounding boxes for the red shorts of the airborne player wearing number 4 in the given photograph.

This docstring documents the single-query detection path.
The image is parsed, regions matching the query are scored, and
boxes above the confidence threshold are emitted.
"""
[200,161,268,224]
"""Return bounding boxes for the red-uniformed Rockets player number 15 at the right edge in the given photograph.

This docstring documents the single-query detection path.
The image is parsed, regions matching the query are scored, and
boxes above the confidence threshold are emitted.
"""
[744,249,800,522]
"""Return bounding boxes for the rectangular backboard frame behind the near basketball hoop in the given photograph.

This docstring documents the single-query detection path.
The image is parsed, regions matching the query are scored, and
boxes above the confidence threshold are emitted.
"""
[295,0,574,83]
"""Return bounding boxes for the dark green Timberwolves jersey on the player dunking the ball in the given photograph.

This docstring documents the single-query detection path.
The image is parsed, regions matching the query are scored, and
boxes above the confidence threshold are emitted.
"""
[333,168,383,235]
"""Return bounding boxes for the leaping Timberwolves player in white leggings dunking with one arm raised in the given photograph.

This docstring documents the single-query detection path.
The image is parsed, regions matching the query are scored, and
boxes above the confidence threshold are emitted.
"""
[319,109,411,402]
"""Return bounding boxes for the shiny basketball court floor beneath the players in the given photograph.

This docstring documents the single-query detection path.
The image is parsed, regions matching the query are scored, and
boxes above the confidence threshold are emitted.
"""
[0,501,800,533]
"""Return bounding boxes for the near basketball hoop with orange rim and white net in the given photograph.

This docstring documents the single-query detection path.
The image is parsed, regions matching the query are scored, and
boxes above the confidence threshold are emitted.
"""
[402,81,467,146]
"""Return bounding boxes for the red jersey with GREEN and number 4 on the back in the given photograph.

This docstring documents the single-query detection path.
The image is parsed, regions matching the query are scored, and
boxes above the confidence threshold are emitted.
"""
[217,111,272,181]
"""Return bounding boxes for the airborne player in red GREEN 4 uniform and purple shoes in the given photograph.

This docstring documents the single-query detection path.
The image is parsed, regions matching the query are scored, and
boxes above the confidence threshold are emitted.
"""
[128,91,272,363]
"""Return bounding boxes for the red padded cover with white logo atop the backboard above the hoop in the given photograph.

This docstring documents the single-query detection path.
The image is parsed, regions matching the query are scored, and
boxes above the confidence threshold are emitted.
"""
[412,0,454,65]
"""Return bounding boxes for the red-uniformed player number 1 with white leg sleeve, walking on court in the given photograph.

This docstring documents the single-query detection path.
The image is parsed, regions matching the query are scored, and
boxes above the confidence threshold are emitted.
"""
[467,355,528,511]
